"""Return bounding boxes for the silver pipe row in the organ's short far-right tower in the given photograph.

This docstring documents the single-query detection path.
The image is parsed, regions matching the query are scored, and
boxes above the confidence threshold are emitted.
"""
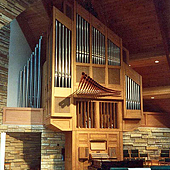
[125,75,141,110]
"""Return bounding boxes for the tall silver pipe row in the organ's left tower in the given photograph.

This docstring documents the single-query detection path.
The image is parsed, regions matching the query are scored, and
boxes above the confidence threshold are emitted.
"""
[54,20,71,88]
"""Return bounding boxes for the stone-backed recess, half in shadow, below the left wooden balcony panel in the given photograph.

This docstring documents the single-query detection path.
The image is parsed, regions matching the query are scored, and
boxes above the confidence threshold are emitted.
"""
[5,132,41,170]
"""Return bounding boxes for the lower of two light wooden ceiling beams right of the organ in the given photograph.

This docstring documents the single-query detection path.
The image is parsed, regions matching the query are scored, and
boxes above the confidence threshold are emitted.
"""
[142,86,170,99]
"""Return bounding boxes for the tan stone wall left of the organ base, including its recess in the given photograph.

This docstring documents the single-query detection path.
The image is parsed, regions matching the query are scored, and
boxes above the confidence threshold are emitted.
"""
[0,125,65,170]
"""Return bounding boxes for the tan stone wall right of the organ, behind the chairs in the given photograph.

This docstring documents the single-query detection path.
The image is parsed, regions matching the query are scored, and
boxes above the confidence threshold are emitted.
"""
[123,127,170,159]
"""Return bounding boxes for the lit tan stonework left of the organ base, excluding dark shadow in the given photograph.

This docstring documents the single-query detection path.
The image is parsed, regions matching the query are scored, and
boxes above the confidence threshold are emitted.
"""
[0,125,65,170]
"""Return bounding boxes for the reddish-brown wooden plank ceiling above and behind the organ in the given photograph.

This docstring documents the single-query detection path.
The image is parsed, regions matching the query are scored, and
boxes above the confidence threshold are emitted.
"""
[1,0,170,113]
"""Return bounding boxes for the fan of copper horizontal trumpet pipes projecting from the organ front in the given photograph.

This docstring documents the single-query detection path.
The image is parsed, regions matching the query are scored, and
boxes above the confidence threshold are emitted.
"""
[77,72,121,96]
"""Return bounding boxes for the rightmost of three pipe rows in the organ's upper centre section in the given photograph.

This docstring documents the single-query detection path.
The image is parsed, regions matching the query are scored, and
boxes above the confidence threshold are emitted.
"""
[107,39,120,66]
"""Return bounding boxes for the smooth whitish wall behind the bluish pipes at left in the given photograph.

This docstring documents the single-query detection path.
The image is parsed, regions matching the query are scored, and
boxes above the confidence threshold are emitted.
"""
[7,19,31,107]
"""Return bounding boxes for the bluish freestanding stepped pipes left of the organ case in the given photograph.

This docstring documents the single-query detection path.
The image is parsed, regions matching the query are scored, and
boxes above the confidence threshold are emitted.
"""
[18,36,42,108]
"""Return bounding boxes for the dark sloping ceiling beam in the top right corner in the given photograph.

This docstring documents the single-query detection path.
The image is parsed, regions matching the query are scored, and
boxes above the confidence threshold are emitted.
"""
[153,0,170,68]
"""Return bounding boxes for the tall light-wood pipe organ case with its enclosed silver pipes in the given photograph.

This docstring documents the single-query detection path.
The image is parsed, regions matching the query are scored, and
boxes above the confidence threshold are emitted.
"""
[42,2,142,170]
